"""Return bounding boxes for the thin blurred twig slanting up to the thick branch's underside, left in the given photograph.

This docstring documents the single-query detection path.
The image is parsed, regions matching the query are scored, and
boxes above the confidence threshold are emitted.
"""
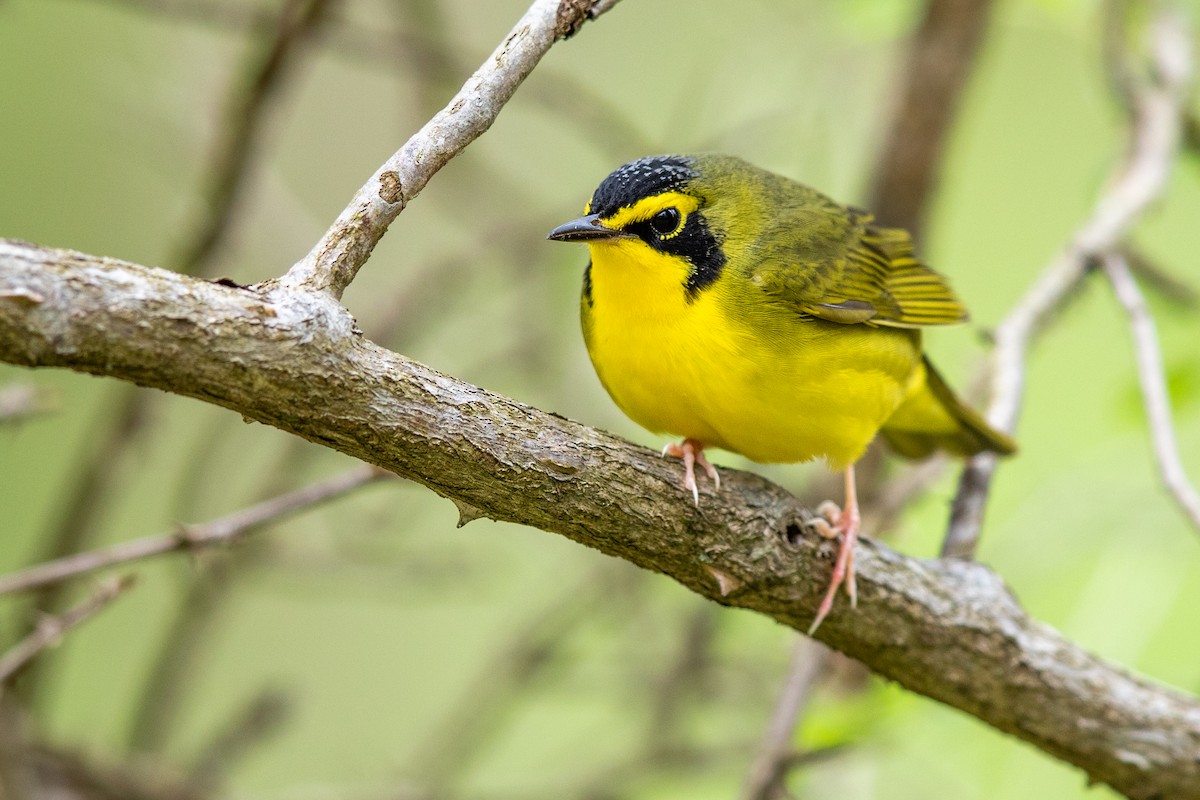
[0,465,390,595]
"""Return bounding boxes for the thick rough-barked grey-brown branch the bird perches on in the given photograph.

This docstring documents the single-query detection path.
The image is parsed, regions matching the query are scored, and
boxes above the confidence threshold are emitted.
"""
[0,241,1200,798]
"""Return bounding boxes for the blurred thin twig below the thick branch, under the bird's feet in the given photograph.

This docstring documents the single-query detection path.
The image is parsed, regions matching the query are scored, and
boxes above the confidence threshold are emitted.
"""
[742,637,829,800]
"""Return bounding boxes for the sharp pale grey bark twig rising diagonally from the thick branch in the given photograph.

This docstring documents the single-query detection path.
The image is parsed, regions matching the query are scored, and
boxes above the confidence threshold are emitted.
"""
[281,0,613,297]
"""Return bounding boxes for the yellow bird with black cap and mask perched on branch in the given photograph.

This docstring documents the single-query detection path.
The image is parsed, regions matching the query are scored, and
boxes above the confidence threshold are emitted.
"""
[547,154,1016,634]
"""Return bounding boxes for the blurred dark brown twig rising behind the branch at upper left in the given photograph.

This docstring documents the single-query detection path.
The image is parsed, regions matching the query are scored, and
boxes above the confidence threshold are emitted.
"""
[172,0,334,275]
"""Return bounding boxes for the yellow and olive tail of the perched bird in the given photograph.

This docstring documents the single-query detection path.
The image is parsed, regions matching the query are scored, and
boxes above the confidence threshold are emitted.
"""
[881,359,1016,458]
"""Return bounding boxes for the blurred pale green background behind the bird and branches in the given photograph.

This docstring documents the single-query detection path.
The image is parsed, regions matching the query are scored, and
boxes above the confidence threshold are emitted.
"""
[0,0,1200,800]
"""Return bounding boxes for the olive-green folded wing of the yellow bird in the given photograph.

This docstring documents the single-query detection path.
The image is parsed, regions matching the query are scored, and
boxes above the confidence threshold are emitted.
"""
[752,200,967,327]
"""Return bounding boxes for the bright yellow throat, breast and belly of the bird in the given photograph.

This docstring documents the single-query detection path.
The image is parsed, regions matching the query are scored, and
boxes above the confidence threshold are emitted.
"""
[582,243,920,468]
